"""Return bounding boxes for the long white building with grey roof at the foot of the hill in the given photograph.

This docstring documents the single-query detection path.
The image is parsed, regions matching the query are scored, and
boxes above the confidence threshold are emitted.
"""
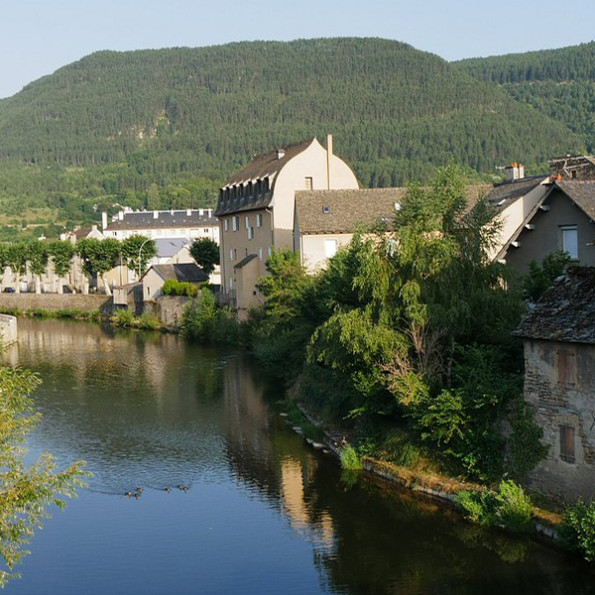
[102,208,219,243]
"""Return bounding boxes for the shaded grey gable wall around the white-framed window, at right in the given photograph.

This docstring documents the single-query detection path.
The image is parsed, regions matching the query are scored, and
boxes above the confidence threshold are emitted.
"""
[505,190,595,274]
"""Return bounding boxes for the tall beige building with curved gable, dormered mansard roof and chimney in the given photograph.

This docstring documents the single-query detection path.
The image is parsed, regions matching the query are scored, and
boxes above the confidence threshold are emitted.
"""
[215,136,359,317]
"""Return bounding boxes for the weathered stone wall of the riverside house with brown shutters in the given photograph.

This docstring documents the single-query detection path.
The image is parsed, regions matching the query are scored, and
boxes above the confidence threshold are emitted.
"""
[524,340,595,502]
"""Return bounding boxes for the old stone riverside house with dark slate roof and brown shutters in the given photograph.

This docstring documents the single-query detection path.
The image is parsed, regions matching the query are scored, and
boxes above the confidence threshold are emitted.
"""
[514,267,595,501]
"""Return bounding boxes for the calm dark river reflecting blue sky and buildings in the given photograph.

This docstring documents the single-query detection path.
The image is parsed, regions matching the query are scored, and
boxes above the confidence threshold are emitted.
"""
[5,320,595,595]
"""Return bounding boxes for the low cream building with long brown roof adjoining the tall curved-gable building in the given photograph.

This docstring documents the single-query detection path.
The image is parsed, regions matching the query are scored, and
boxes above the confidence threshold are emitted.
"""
[293,188,406,273]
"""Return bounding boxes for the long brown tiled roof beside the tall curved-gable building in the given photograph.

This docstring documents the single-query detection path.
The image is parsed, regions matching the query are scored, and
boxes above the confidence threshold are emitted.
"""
[295,188,407,234]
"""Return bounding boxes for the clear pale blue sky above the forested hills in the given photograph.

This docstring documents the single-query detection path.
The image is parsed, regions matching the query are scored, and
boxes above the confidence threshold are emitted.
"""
[0,0,595,97]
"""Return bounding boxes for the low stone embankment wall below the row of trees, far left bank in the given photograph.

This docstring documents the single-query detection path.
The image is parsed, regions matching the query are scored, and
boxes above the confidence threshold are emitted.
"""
[0,293,112,313]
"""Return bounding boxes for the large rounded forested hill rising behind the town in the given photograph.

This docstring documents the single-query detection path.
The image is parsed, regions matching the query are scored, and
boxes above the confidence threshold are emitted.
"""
[0,39,582,238]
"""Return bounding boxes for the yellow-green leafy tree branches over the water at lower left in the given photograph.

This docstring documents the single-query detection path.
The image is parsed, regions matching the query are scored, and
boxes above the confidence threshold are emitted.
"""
[0,367,87,587]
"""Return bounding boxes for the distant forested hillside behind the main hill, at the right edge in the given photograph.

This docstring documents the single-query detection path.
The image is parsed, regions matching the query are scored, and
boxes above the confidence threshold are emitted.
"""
[453,42,595,153]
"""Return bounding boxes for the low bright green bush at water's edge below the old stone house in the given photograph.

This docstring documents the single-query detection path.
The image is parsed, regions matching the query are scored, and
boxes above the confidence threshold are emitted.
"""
[455,480,533,533]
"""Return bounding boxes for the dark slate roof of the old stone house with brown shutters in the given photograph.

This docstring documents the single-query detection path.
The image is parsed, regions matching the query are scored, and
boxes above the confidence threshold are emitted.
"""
[513,267,595,344]
